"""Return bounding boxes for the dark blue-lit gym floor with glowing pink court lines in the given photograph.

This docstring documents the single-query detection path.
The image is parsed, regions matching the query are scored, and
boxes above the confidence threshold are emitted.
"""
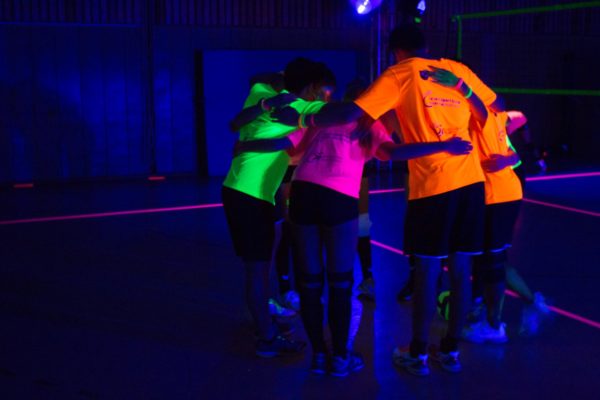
[0,171,600,399]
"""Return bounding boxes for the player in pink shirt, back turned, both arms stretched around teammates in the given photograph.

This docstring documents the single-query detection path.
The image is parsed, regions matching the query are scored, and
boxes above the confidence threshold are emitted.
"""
[236,82,472,376]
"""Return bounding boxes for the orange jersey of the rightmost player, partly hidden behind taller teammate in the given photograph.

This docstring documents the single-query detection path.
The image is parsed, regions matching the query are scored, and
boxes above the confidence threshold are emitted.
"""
[472,109,523,204]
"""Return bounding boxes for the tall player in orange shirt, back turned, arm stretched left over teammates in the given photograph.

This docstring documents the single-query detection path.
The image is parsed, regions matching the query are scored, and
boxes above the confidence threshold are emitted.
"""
[275,25,496,375]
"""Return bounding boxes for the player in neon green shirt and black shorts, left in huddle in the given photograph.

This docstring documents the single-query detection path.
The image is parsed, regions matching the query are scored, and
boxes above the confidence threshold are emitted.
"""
[222,58,336,357]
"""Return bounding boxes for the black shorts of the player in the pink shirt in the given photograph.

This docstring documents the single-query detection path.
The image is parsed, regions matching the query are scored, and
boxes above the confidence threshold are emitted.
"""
[290,181,358,226]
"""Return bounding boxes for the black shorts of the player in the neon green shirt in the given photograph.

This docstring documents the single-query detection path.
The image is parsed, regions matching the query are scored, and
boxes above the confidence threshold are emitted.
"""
[221,186,275,262]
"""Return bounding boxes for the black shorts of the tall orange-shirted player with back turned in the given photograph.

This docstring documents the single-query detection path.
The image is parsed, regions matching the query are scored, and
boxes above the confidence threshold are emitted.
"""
[404,182,485,258]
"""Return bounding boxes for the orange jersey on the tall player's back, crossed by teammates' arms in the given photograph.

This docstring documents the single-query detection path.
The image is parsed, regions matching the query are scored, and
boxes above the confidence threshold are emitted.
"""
[355,57,496,200]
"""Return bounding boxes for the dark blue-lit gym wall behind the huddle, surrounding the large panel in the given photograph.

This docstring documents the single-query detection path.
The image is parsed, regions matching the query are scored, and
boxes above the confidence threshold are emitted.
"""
[0,0,600,183]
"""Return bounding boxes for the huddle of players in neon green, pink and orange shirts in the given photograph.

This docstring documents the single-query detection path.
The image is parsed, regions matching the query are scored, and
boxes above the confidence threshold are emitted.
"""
[222,25,547,376]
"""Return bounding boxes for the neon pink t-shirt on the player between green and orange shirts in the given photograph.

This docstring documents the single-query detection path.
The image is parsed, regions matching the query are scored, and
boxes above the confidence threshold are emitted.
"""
[288,121,392,198]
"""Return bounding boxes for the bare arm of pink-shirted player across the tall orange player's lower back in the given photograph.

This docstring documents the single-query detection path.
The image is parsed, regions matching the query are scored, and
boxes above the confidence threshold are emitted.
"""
[375,138,473,160]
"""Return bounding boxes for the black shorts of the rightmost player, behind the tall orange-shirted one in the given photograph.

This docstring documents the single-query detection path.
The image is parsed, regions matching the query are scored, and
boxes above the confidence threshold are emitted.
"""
[483,200,521,253]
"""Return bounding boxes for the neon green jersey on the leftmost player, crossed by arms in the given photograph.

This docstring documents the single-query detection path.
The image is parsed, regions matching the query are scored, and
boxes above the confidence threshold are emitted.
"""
[223,83,325,204]
